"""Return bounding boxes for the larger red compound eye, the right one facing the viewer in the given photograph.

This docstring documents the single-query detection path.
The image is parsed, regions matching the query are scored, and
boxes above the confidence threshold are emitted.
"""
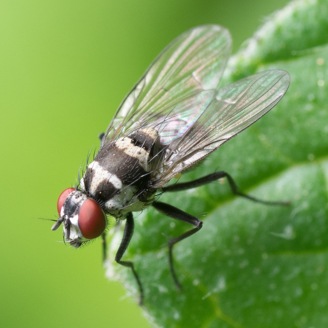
[78,198,106,239]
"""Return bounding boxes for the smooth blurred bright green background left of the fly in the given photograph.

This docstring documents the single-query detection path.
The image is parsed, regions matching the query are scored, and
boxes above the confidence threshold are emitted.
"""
[0,0,287,328]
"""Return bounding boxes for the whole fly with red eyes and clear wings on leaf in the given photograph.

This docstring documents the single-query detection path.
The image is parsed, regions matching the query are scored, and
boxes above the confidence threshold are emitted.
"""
[52,25,289,303]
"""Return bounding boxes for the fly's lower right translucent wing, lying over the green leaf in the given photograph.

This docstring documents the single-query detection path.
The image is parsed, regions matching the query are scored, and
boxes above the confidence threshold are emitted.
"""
[155,70,289,188]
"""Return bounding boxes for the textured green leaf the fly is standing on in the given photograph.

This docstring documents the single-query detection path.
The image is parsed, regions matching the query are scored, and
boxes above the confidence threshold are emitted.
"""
[106,1,328,328]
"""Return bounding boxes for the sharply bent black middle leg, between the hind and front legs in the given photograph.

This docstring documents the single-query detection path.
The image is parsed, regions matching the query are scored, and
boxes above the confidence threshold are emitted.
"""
[152,202,203,289]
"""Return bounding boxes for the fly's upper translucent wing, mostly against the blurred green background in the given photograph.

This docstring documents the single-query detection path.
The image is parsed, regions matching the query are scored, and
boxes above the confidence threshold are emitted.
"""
[103,25,231,145]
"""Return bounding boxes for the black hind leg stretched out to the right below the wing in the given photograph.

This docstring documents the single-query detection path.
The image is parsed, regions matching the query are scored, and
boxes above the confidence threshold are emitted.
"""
[162,171,289,206]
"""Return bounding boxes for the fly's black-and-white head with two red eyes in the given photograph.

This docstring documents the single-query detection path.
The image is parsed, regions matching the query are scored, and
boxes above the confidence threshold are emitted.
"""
[52,188,107,247]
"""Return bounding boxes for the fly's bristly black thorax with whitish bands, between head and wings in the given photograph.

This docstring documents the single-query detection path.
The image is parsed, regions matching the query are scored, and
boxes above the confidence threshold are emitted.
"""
[80,128,160,217]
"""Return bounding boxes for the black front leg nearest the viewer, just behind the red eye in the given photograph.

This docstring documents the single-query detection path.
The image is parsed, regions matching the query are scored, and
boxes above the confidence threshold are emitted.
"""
[115,213,144,305]
